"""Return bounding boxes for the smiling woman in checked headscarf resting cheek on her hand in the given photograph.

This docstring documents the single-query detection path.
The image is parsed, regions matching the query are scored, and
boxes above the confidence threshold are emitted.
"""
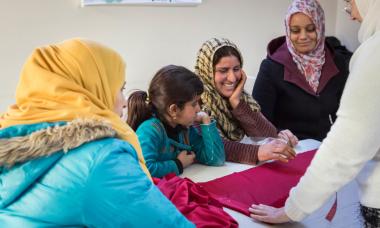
[195,38,297,164]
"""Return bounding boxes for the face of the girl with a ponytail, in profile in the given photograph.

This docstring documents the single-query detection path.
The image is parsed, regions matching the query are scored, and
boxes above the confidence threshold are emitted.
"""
[174,96,201,127]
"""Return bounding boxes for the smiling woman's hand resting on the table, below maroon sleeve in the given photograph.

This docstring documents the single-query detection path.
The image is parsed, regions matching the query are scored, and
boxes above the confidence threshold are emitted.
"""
[258,139,296,162]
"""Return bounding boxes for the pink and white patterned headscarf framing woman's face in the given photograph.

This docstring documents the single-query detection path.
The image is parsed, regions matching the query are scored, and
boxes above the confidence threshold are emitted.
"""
[285,0,325,92]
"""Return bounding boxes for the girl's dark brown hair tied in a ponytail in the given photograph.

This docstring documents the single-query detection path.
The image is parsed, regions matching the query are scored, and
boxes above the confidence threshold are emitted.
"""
[127,65,203,130]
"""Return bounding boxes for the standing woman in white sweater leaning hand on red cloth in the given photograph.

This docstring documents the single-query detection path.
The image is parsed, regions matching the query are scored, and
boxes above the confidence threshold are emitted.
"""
[250,0,380,227]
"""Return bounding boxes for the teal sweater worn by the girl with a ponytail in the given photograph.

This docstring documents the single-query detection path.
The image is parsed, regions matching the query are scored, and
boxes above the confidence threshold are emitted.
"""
[136,117,225,177]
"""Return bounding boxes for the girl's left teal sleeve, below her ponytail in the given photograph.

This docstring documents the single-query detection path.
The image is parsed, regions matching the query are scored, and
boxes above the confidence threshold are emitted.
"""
[136,120,180,177]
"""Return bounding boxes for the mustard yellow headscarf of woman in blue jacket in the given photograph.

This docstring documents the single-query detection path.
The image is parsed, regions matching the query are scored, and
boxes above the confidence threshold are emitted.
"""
[0,39,150,180]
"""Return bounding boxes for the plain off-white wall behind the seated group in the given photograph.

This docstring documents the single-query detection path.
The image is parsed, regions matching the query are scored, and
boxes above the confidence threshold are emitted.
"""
[0,0,350,112]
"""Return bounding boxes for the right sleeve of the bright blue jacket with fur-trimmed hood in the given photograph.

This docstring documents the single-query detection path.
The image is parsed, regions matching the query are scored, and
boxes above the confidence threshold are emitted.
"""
[83,142,195,227]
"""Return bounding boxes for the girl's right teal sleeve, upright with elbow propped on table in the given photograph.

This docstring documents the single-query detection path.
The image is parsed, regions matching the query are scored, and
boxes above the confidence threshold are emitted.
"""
[189,120,226,166]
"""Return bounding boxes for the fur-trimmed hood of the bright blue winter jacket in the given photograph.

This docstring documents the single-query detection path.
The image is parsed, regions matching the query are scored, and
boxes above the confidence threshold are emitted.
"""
[0,119,116,209]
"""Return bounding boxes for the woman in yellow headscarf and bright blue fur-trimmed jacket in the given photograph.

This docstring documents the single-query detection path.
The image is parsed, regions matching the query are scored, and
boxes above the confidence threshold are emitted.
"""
[0,39,194,227]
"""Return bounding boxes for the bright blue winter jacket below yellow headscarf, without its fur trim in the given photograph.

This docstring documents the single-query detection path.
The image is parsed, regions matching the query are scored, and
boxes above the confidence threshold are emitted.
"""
[0,120,194,227]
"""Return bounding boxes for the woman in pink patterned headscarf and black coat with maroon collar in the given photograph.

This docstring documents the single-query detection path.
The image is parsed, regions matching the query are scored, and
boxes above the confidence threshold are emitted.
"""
[252,0,351,141]
